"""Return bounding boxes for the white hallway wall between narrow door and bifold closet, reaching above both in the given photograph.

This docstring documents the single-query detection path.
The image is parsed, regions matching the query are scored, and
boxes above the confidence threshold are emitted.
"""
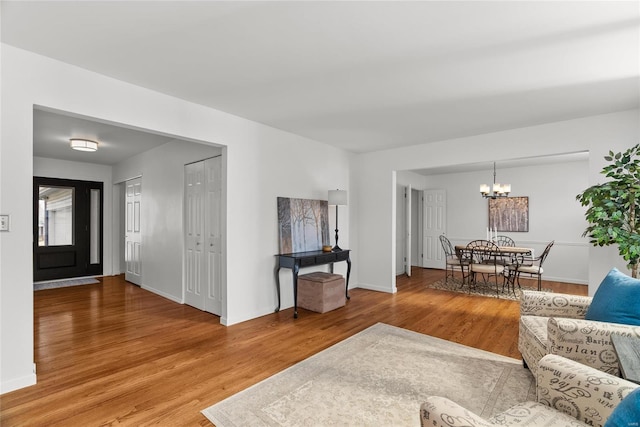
[113,141,222,302]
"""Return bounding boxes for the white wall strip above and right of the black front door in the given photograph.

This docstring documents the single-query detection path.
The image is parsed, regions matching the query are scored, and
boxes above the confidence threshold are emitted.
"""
[33,157,118,275]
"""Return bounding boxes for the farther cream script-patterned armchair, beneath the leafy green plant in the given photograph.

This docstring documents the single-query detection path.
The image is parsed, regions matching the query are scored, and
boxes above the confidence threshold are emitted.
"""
[518,291,640,375]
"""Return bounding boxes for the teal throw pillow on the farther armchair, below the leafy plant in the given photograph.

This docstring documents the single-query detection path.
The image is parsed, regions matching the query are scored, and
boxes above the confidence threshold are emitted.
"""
[585,268,640,326]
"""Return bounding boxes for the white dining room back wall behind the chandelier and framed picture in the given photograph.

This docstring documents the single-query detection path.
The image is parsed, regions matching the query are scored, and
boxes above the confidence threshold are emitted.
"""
[416,156,589,284]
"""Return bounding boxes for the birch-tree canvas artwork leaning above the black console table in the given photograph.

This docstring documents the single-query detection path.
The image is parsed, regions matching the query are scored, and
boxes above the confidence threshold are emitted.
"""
[278,197,329,254]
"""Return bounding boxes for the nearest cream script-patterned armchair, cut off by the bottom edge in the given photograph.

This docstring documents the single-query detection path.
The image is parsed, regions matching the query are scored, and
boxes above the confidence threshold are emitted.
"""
[420,354,640,427]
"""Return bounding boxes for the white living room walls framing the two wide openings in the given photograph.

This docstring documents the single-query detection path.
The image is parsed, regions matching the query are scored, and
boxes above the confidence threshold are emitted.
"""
[0,44,640,392]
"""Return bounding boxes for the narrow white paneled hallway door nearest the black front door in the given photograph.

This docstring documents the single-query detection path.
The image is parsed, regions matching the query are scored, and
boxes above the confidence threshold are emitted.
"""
[124,178,142,286]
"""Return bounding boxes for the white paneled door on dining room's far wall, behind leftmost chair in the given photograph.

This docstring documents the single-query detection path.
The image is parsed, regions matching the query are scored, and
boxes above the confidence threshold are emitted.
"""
[422,190,447,268]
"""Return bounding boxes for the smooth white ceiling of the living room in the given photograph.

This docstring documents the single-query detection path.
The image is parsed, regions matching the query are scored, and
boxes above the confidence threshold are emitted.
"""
[1,1,640,162]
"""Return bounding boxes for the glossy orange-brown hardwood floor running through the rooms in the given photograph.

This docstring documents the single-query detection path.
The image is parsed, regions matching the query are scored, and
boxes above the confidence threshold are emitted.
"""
[0,268,587,426]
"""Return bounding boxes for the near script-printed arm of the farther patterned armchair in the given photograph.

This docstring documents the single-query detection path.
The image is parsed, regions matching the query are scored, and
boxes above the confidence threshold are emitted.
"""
[547,317,640,375]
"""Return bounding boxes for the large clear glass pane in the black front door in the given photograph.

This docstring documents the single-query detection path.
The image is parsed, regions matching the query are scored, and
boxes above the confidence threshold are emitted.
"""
[38,186,74,246]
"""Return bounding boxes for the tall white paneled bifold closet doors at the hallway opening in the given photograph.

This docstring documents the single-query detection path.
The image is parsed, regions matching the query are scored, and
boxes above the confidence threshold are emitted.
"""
[185,157,222,315]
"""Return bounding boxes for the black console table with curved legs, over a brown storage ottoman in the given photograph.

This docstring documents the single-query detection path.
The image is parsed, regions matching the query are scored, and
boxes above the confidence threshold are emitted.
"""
[275,249,351,319]
